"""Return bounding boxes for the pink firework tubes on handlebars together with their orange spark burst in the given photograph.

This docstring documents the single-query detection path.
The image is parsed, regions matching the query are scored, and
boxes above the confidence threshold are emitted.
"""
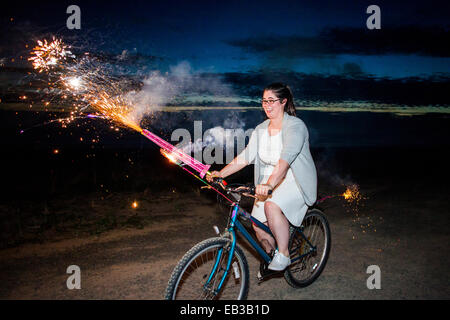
[29,39,214,178]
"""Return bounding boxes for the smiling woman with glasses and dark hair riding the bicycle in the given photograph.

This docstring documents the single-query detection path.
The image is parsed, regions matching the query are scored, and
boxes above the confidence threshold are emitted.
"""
[207,83,317,271]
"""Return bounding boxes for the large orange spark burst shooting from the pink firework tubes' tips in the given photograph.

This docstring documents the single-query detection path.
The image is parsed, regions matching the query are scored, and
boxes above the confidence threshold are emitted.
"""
[28,38,146,132]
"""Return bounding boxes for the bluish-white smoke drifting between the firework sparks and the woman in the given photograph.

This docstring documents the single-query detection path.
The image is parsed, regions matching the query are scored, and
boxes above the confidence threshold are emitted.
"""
[126,61,250,160]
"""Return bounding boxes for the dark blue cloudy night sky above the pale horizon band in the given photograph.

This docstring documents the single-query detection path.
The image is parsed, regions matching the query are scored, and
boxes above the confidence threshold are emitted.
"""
[0,1,450,105]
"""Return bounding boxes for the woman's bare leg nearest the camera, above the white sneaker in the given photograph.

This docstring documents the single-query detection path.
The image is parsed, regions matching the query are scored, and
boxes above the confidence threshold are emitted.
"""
[264,201,289,257]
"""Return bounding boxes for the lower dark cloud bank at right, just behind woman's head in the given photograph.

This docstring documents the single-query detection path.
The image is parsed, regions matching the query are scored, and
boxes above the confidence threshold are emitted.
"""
[223,70,450,106]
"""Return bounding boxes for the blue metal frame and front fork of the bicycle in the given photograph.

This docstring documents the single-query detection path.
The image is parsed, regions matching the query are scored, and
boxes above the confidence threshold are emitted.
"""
[204,202,316,294]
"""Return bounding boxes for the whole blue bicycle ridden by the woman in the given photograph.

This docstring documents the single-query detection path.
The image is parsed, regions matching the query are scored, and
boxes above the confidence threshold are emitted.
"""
[165,178,331,300]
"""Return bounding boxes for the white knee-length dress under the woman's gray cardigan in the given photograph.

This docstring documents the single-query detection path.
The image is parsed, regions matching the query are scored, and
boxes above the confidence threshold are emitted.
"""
[252,130,308,226]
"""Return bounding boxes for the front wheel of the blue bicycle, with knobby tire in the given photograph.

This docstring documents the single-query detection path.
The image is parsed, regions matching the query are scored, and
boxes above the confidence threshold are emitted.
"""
[165,238,249,300]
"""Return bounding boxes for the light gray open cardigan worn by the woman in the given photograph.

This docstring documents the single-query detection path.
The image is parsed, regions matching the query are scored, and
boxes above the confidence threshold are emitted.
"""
[237,112,317,206]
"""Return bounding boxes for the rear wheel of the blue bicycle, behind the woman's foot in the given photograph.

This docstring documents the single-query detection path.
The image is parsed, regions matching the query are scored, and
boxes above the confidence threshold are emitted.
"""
[284,209,331,288]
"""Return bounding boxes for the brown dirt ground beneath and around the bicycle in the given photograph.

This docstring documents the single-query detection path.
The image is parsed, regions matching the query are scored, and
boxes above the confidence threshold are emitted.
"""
[0,185,450,300]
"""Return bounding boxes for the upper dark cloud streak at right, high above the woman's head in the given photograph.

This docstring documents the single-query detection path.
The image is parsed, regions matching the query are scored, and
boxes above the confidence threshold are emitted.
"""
[226,26,450,59]
